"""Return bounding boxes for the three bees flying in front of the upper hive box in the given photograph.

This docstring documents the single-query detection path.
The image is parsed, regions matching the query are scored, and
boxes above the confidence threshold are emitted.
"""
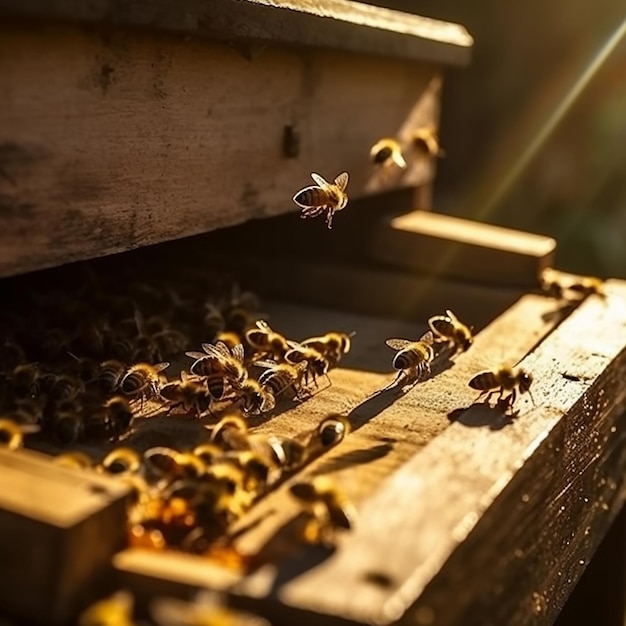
[293,126,444,229]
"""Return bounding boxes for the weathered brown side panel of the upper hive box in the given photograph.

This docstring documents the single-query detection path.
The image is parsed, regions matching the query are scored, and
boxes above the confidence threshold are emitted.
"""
[0,23,441,275]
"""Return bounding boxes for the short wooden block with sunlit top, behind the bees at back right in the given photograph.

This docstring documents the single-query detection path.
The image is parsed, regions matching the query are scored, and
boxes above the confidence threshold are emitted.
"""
[370,211,556,287]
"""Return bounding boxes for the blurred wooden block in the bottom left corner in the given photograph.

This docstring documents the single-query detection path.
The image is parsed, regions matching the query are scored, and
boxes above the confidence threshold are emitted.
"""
[0,449,129,624]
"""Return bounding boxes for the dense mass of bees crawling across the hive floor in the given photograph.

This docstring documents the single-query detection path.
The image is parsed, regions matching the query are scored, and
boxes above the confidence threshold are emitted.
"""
[0,264,352,553]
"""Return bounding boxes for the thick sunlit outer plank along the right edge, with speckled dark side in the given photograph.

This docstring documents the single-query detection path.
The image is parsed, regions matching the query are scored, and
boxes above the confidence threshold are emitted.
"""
[249,282,626,624]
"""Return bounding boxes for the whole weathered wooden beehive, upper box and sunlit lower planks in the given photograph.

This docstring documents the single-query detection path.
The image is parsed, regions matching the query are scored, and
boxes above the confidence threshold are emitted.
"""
[0,0,626,626]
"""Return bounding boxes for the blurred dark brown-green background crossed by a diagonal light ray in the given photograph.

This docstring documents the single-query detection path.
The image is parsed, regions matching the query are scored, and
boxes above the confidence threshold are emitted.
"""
[358,0,626,277]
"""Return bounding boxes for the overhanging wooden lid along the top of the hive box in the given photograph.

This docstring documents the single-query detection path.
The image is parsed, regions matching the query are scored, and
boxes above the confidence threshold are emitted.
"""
[0,0,473,64]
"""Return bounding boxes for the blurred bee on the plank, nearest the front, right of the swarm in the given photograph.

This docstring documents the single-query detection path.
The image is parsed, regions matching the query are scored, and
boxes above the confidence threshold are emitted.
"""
[289,476,356,545]
